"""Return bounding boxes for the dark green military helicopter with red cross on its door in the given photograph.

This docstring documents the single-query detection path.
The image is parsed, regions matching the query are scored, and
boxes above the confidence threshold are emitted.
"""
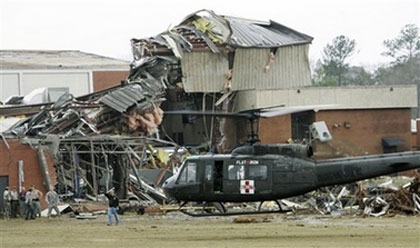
[163,108,420,216]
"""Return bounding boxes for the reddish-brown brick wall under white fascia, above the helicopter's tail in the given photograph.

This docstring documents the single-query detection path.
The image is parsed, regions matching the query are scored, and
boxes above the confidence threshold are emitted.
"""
[315,108,411,156]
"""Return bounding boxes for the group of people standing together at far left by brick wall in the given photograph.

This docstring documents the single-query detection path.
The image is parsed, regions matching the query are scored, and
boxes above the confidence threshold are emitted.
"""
[3,185,60,220]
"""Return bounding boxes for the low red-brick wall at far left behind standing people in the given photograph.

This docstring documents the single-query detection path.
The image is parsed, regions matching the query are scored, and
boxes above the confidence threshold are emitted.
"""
[0,139,56,208]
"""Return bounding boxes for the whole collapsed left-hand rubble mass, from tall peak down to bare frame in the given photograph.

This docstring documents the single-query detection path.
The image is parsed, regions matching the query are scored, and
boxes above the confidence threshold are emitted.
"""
[2,26,181,207]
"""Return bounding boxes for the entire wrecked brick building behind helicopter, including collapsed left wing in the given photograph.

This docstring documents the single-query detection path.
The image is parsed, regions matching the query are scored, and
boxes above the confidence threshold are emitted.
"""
[0,10,417,213]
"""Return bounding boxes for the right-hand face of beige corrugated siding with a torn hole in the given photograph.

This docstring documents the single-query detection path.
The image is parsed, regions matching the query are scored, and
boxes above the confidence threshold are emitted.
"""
[232,44,311,90]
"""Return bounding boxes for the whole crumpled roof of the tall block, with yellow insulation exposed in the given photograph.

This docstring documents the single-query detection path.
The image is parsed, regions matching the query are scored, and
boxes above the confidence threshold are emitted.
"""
[132,10,313,59]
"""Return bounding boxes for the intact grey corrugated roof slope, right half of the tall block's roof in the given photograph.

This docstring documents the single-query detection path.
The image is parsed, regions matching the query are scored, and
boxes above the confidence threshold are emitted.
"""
[225,17,313,47]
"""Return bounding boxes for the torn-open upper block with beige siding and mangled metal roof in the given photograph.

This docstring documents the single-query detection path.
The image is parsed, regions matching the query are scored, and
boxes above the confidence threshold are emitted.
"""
[131,10,313,93]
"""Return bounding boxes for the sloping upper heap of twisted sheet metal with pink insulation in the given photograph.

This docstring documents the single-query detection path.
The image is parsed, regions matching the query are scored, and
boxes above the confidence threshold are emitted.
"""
[3,82,164,138]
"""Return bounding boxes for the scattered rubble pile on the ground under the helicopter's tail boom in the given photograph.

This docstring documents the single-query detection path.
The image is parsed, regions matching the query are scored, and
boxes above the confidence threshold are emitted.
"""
[281,174,420,217]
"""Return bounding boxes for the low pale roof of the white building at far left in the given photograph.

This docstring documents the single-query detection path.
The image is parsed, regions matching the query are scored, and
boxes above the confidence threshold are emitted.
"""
[0,50,130,70]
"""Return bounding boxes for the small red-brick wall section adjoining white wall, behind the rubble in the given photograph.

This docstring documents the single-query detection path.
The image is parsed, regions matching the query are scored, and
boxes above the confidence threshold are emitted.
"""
[92,71,128,91]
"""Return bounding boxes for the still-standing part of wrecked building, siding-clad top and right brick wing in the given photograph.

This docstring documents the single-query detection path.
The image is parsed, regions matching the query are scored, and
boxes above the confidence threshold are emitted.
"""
[132,10,417,157]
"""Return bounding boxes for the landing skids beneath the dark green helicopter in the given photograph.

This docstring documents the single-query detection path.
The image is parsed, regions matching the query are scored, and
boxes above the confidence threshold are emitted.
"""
[179,201,291,217]
